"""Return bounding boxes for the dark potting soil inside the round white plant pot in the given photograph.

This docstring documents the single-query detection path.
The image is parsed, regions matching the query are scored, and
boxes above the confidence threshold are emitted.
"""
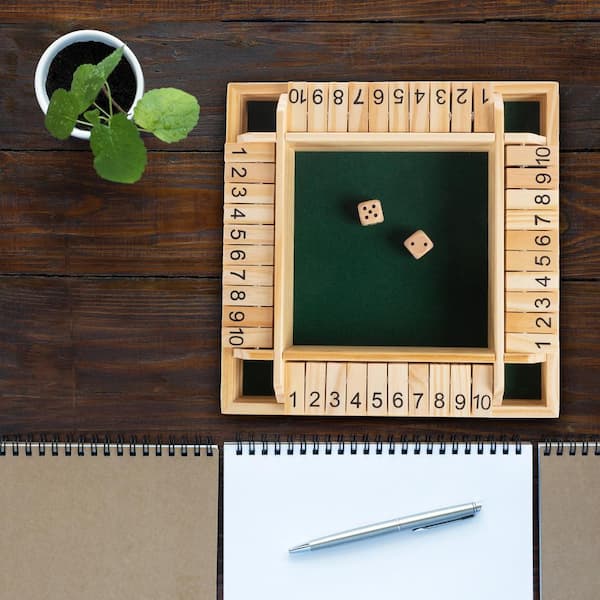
[46,42,135,128]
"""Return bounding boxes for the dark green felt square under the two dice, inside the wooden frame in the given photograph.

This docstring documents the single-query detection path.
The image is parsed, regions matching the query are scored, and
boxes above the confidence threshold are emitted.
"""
[293,151,488,348]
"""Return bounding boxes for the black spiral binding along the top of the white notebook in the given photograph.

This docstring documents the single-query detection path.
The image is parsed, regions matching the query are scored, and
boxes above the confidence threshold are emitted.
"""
[234,434,522,456]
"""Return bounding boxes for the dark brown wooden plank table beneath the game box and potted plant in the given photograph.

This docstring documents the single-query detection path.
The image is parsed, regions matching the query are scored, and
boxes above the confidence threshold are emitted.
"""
[0,0,600,596]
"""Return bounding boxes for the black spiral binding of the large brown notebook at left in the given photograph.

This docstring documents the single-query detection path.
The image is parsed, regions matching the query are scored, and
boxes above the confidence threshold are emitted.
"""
[0,436,215,457]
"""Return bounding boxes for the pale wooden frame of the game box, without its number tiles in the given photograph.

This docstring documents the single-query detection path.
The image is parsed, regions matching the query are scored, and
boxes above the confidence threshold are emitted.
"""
[221,82,560,417]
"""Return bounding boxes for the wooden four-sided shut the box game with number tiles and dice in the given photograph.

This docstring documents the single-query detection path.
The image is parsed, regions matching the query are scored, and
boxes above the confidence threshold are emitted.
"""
[221,81,560,418]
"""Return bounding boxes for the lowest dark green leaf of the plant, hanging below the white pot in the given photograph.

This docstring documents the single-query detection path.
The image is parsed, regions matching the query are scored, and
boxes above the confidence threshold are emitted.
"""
[90,113,146,183]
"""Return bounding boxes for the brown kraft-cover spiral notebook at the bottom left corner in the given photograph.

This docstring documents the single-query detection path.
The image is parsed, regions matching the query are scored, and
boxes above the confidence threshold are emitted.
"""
[0,444,219,600]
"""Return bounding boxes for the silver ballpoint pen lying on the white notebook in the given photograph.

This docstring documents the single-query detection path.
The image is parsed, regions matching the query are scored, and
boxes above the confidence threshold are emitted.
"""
[289,502,481,554]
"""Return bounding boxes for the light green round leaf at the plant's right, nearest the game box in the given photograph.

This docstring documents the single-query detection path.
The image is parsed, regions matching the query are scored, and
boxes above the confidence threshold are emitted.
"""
[134,88,200,143]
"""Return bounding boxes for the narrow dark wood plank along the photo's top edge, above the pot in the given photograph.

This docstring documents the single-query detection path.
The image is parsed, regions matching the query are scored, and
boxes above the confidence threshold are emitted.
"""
[4,0,600,22]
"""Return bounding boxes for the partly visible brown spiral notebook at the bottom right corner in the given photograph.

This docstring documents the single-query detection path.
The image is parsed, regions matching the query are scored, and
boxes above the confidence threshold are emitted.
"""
[539,443,600,600]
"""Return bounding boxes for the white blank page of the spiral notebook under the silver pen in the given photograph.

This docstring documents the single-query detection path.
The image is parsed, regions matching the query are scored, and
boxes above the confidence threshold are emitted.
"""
[223,443,533,600]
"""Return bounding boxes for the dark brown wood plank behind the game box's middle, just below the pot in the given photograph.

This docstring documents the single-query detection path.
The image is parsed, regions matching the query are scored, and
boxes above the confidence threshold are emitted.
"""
[0,151,600,280]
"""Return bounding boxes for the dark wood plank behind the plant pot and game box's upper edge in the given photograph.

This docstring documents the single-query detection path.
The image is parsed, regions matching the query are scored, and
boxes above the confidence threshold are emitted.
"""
[0,22,600,151]
